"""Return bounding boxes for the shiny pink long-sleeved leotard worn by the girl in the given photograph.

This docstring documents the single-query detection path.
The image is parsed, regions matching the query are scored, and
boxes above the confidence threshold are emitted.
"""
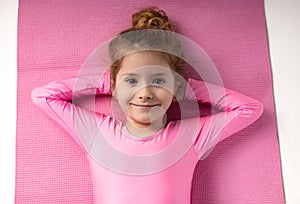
[31,74,263,204]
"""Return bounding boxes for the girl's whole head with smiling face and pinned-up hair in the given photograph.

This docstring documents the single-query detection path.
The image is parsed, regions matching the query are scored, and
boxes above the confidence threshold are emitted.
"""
[109,8,185,131]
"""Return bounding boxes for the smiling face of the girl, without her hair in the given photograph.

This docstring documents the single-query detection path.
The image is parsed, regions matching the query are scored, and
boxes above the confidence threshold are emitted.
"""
[113,51,179,131]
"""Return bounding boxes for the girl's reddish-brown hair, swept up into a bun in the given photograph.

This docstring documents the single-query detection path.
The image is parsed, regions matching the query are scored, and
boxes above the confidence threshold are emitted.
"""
[109,7,185,90]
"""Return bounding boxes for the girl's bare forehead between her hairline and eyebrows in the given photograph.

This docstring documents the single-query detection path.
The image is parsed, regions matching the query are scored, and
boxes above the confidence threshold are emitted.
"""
[119,51,172,75]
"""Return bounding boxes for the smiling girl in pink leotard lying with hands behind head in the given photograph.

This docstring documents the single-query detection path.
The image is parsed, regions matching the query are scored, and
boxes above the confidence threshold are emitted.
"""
[32,8,263,204]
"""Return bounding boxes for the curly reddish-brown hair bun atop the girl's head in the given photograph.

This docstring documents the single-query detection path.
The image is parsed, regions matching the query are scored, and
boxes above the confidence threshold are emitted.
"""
[132,7,174,31]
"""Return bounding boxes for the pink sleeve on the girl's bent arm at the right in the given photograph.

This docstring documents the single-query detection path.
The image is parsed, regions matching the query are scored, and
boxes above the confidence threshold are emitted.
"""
[185,79,263,159]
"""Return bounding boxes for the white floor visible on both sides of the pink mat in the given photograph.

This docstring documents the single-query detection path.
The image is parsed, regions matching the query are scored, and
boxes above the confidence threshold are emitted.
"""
[0,0,300,204]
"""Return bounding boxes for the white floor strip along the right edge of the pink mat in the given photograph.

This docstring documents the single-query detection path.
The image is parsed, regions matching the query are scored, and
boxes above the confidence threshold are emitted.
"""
[265,0,300,204]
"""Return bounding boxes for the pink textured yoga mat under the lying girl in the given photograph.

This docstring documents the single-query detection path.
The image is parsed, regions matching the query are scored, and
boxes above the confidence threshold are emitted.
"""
[15,0,284,204]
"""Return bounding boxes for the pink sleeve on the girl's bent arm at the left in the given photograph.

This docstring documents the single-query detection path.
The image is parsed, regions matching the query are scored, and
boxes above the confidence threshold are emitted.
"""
[31,72,111,148]
